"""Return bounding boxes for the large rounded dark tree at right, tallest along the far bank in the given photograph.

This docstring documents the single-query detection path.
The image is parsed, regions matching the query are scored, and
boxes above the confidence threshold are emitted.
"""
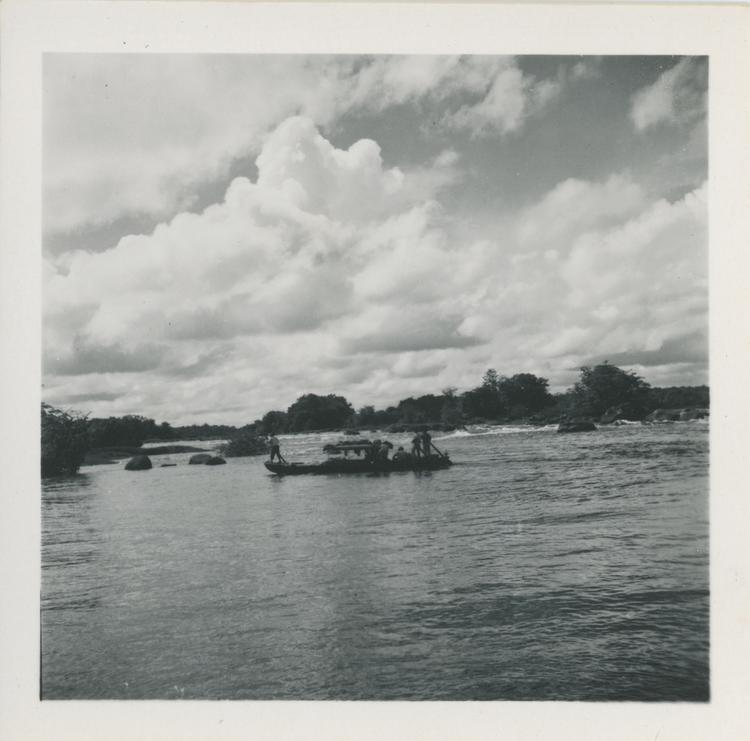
[573,361,651,419]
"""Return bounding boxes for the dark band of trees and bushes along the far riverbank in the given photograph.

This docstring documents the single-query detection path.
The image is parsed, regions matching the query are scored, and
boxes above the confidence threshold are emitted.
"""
[42,362,709,476]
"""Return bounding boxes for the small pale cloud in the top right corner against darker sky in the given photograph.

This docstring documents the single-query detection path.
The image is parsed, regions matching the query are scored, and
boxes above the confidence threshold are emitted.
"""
[630,57,708,131]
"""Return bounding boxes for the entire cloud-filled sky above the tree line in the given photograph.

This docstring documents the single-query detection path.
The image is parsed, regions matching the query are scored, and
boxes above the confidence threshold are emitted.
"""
[42,54,708,425]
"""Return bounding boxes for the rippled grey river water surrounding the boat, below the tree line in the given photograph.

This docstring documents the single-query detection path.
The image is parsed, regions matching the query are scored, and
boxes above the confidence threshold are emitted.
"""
[42,423,709,700]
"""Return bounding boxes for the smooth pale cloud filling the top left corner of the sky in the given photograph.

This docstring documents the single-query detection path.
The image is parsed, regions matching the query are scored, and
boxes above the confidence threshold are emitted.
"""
[44,54,306,231]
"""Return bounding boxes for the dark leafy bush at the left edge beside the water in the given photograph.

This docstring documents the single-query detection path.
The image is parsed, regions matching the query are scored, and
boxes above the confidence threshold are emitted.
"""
[41,404,88,477]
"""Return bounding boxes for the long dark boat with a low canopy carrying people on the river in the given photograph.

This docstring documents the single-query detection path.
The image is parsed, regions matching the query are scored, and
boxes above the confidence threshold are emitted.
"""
[263,440,453,476]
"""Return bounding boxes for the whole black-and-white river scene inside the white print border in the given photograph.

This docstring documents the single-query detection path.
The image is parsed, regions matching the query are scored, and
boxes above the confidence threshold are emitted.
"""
[40,53,710,703]
